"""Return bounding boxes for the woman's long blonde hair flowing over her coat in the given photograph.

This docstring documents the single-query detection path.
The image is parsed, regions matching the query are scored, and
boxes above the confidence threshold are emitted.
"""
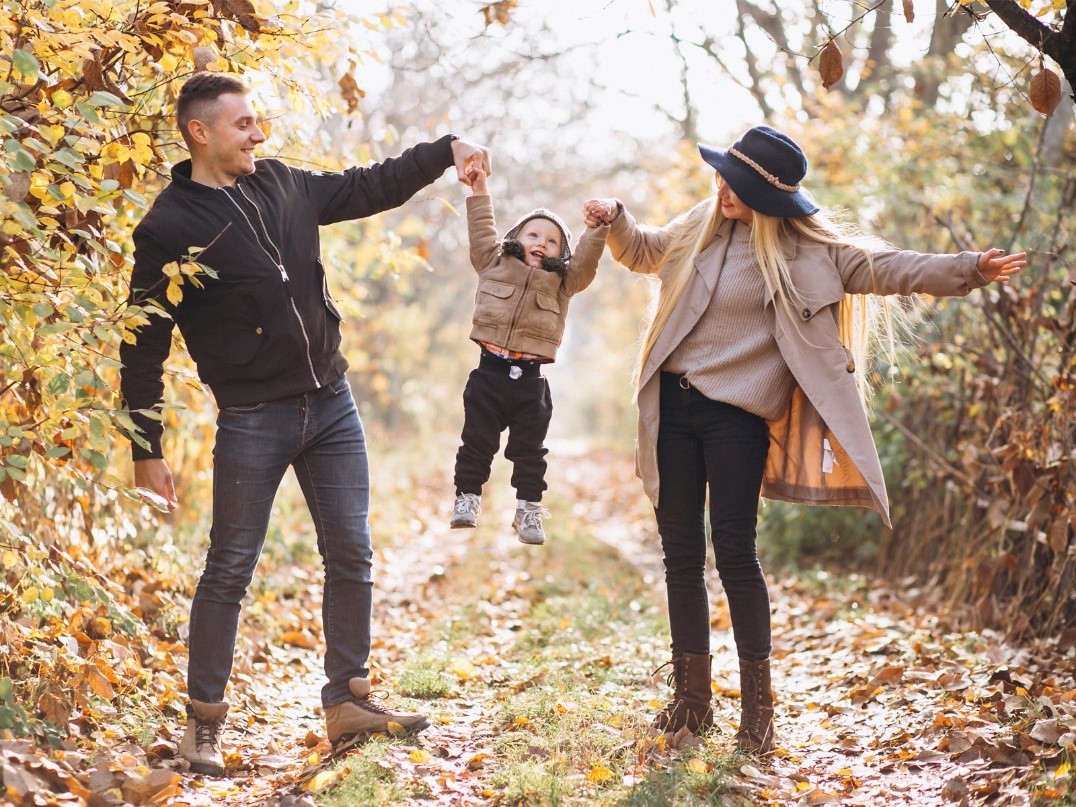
[635,188,915,406]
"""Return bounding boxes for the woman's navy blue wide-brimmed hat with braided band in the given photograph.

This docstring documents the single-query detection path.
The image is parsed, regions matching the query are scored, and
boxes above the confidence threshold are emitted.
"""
[698,126,819,218]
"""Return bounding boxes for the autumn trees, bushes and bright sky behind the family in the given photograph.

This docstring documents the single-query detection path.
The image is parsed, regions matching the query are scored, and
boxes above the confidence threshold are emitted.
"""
[0,0,1076,804]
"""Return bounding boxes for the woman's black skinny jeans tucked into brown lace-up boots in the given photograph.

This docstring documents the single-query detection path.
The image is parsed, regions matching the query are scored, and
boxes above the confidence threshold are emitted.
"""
[655,372,770,660]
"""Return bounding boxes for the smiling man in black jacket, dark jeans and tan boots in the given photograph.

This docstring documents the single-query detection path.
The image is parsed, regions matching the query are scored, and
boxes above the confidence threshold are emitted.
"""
[121,73,490,775]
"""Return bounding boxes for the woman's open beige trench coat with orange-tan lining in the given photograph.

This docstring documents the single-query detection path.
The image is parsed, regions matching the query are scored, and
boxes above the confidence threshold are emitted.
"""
[609,210,987,526]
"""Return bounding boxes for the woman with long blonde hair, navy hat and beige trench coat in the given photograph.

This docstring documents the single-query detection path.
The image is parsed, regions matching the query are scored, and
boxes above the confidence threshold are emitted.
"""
[584,126,1025,753]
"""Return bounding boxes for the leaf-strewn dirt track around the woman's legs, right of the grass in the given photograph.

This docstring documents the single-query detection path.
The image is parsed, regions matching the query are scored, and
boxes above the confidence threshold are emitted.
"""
[572,443,1076,806]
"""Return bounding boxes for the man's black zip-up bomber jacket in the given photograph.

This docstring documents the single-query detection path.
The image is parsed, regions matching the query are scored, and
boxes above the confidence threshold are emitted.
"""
[119,136,454,459]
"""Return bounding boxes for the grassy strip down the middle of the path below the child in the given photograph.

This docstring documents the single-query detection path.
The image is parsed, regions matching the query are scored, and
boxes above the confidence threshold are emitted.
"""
[318,479,739,807]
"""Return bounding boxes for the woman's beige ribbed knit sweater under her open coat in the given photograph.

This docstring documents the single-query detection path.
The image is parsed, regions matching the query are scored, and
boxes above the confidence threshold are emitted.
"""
[662,224,795,421]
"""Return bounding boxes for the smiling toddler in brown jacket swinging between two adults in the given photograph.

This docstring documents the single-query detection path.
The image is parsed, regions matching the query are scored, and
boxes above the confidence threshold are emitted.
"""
[452,168,609,544]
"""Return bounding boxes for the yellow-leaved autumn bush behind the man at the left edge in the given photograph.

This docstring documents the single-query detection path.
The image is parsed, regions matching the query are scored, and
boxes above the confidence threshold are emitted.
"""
[0,0,400,742]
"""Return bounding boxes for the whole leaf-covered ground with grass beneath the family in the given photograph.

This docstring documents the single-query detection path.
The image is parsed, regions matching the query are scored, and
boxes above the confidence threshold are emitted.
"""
[0,444,1076,806]
